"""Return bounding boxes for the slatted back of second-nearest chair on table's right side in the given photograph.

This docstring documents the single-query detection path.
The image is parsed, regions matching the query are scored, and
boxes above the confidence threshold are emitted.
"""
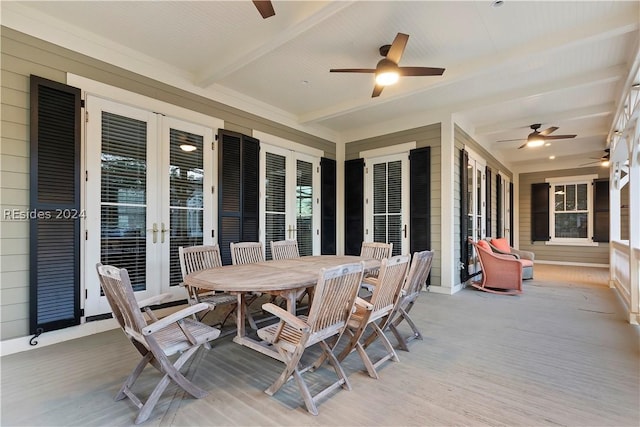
[369,255,411,318]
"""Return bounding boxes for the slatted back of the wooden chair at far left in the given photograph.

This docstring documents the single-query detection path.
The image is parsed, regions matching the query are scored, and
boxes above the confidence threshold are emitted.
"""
[96,264,147,343]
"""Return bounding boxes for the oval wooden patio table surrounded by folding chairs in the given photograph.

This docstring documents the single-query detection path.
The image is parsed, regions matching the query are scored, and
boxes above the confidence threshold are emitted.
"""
[184,255,380,360]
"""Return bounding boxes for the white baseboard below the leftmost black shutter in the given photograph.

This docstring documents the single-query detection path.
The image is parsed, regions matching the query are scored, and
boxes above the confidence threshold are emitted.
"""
[0,319,120,357]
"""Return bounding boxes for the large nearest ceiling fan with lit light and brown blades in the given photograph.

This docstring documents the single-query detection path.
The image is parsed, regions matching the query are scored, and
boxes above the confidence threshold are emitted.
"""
[329,33,444,98]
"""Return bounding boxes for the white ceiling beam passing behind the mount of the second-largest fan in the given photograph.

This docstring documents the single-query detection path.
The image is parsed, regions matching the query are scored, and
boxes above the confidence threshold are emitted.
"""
[475,102,616,135]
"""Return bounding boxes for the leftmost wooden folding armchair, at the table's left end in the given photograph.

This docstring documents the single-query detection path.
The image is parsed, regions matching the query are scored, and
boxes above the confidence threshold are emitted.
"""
[96,263,220,424]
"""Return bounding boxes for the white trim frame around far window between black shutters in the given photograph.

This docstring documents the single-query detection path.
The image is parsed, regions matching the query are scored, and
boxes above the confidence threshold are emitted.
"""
[545,174,598,246]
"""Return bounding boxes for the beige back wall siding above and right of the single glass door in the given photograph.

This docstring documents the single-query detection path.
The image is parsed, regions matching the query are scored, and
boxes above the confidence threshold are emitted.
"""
[345,123,442,286]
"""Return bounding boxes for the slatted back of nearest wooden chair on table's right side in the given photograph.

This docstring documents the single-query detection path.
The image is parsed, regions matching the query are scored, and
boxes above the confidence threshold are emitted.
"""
[307,262,364,333]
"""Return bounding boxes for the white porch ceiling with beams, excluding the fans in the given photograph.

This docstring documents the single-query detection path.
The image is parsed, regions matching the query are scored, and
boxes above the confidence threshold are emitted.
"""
[1,0,640,170]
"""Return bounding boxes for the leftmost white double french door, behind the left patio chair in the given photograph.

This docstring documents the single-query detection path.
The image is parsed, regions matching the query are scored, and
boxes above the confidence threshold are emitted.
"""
[85,96,214,316]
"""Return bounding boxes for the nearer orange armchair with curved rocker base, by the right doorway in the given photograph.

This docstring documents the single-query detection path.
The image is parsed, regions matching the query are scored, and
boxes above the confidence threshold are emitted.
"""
[471,240,522,295]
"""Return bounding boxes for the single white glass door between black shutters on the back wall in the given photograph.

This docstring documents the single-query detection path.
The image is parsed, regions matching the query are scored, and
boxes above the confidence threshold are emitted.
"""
[364,153,409,255]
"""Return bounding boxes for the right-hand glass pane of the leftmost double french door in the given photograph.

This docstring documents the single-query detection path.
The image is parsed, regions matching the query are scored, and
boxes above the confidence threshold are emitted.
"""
[168,129,204,286]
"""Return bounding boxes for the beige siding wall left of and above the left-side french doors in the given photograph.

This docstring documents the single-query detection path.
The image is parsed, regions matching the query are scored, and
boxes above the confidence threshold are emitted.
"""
[0,27,336,340]
